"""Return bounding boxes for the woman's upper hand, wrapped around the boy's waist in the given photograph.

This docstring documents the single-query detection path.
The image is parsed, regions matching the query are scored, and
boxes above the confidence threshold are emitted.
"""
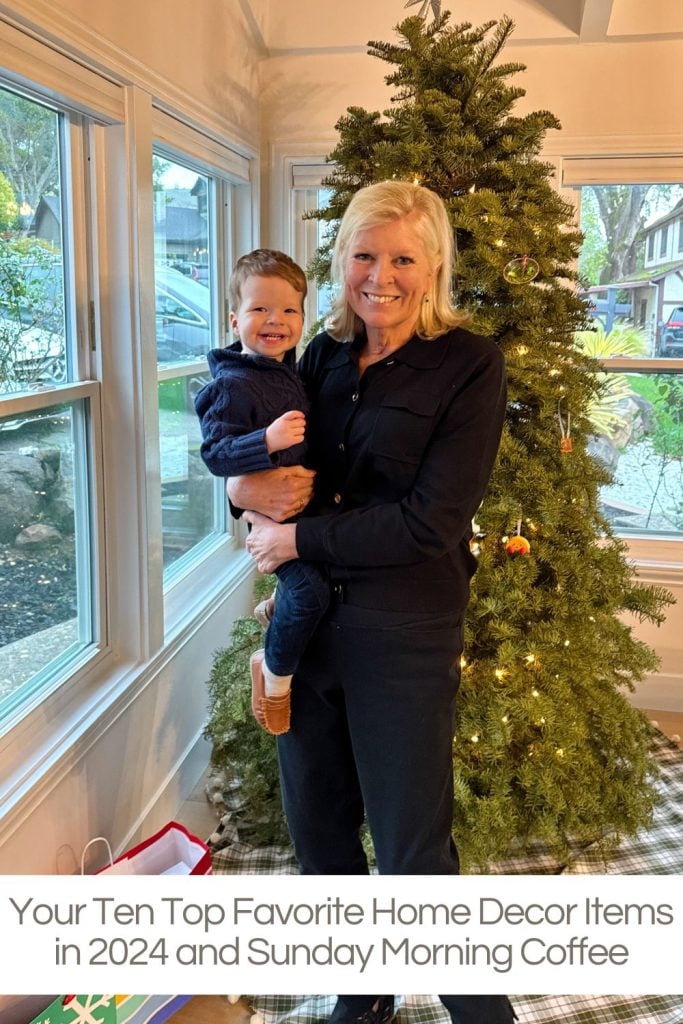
[227,466,315,522]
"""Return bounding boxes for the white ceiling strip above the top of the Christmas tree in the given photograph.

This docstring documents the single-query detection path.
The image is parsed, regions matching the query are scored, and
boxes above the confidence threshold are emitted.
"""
[240,0,683,56]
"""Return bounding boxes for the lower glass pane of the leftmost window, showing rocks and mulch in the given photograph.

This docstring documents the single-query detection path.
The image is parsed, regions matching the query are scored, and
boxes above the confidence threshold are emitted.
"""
[0,402,92,716]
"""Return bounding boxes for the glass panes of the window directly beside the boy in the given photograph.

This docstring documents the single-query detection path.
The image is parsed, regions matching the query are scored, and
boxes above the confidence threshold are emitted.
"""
[154,154,224,570]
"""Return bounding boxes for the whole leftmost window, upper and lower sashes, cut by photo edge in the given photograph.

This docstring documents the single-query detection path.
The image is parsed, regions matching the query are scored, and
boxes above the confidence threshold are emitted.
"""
[0,81,99,719]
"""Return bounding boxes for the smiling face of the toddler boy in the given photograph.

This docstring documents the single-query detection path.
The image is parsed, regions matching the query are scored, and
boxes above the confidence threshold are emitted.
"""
[230,274,303,361]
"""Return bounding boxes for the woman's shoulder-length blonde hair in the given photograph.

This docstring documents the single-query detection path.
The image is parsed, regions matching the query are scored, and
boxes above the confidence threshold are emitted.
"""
[326,181,469,341]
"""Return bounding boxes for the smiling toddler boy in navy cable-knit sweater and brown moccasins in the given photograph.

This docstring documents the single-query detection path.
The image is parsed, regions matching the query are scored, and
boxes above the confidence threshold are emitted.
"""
[195,249,330,735]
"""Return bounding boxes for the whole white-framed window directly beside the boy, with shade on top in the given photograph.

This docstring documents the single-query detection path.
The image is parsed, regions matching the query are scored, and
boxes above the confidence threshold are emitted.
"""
[148,124,252,636]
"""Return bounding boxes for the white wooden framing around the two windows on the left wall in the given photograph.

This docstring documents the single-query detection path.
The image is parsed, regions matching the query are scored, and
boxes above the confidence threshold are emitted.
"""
[0,17,258,827]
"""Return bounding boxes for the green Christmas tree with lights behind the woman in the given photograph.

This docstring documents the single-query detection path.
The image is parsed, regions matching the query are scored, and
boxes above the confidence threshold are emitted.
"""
[206,13,670,868]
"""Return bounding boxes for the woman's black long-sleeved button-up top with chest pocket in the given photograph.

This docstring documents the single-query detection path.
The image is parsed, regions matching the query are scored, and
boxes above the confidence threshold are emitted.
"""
[296,330,505,612]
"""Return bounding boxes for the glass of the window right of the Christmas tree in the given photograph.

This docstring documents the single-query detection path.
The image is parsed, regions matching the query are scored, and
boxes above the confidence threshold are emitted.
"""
[577,184,683,537]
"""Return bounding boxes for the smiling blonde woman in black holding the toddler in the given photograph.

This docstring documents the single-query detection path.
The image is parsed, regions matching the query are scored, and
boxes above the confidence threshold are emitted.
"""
[230,181,513,1024]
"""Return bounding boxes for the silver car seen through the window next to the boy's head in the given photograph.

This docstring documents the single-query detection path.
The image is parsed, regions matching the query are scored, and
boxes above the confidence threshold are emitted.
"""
[155,266,211,362]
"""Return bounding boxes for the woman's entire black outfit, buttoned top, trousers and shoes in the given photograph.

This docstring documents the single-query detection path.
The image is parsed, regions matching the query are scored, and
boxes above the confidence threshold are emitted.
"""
[278,330,512,1024]
